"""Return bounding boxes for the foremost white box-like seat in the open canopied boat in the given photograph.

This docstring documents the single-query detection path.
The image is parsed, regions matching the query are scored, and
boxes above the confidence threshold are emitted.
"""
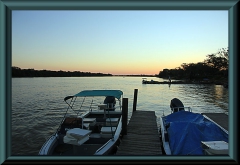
[63,128,91,145]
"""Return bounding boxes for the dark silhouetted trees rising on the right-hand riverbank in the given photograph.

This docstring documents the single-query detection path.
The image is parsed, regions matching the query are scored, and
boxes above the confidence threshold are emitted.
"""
[156,48,229,84]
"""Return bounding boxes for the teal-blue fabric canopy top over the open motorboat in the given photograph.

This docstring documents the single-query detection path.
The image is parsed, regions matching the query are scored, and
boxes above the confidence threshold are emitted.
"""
[64,90,123,101]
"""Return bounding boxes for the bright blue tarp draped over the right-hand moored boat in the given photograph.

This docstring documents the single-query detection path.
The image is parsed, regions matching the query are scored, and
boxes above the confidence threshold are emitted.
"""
[165,111,228,155]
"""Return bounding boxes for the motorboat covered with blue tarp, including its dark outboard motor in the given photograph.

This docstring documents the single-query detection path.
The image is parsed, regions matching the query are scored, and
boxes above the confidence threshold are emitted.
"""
[160,98,228,155]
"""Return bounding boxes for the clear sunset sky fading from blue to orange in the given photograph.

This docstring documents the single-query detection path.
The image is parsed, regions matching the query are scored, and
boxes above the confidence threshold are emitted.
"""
[12,10,228,75]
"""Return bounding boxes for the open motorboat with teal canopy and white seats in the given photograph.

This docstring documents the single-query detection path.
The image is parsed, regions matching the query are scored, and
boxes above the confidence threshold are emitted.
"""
[38,90,123,156]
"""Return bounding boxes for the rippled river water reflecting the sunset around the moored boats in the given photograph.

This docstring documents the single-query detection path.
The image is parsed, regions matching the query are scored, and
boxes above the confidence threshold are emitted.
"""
[11,77,228,155]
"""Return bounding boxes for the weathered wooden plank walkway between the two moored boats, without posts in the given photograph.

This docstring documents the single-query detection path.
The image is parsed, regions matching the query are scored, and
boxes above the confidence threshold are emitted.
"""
[115,110,162,156]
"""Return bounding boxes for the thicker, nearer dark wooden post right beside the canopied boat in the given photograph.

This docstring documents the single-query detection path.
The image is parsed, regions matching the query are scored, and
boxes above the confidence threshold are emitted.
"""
[122,98,128,135]
